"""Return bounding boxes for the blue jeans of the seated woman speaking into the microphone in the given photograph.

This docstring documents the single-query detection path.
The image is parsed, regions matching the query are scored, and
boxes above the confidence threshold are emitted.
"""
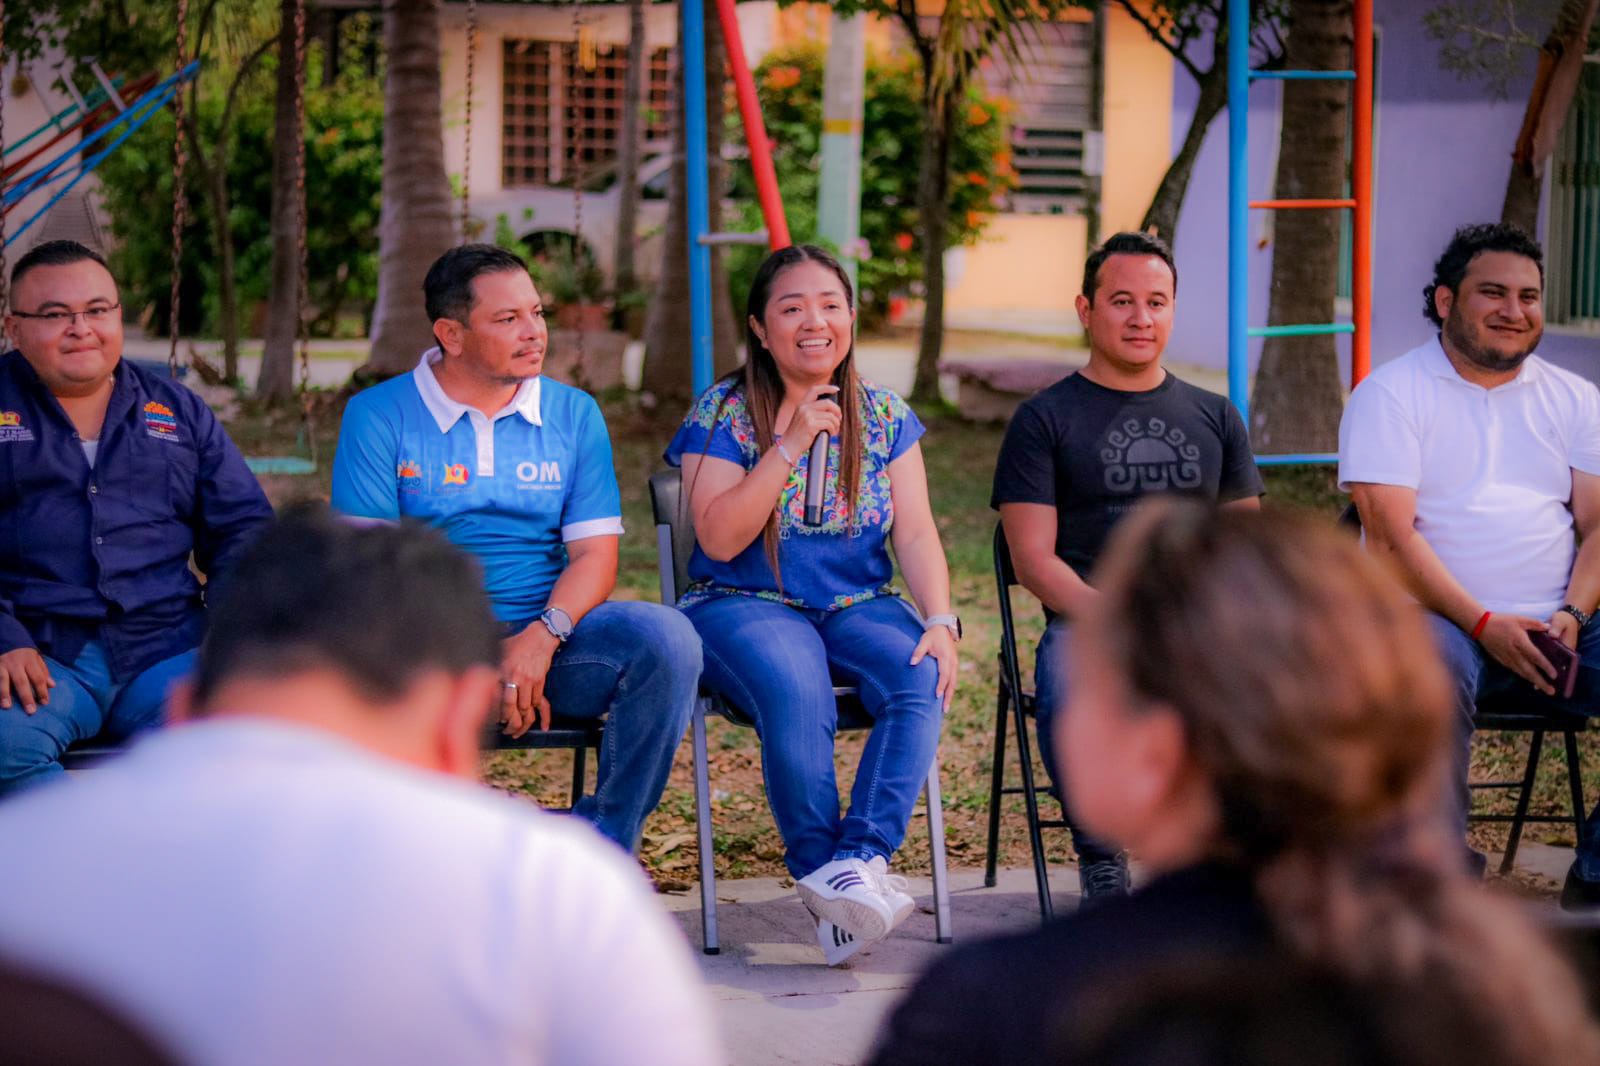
[685,595,944,879]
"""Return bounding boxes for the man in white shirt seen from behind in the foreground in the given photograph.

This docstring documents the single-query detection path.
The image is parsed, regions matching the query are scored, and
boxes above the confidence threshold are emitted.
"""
[0,506,726,1066]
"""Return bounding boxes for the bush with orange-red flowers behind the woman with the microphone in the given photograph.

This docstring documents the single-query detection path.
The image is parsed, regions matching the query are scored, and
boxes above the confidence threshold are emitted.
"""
[728,46,1014,327]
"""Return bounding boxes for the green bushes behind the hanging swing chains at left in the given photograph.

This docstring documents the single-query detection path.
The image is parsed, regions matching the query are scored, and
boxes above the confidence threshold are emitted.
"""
[98,43,382,335]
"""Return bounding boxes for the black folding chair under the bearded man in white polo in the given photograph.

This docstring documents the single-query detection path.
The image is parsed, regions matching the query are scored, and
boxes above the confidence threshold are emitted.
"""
[1339,503,1589,876]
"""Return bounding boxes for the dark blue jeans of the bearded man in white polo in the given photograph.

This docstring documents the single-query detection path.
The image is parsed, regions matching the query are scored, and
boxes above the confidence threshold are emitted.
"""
[1429,615,1600,882]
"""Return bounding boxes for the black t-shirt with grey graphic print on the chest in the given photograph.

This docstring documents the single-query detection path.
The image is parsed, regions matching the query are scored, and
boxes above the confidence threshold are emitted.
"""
[990,375,1264,589]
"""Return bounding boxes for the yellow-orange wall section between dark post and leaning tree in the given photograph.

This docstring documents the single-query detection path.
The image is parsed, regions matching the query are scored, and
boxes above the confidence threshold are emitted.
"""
[1101,5,1174,234]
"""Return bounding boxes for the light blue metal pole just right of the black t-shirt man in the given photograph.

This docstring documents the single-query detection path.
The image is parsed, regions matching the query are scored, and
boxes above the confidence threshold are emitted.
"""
[1227,0,1250,427]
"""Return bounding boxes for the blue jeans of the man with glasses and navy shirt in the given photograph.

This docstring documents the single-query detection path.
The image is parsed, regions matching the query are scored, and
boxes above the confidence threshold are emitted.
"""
[0,640,195,795]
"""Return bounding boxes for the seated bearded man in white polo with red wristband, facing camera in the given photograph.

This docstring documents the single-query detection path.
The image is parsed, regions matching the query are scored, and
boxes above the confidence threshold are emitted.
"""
[1339,224,1600,906]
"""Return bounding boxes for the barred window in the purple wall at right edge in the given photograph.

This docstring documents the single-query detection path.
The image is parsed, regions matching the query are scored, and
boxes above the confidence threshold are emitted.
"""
[1544,62,1600,333]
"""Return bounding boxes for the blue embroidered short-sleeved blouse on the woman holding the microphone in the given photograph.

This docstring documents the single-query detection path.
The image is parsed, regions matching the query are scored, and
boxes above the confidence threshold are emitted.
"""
[666,381,926,611]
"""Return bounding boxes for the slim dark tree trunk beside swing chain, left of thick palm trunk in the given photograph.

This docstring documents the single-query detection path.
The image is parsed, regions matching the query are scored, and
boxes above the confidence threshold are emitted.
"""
[256,0,306,403]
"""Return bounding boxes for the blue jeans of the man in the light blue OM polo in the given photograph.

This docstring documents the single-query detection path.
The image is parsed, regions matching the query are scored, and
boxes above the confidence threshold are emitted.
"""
[528,600,701,852]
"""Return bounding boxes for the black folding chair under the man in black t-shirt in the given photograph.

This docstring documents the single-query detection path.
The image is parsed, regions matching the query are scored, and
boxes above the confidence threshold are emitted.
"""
[984,523,1067,922]
